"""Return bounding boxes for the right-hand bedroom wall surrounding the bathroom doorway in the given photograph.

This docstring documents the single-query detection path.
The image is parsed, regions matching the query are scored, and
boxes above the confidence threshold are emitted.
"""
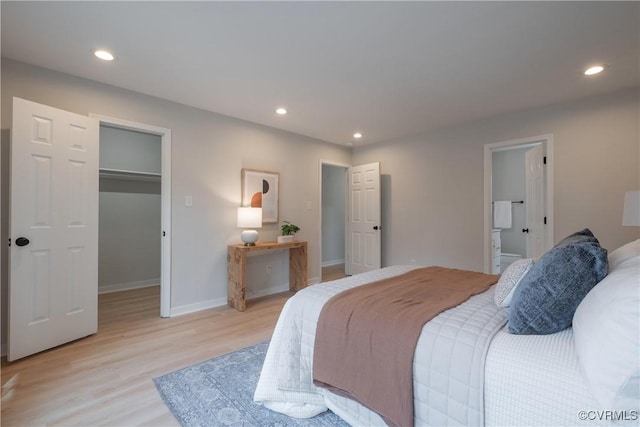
[352,88,640,271]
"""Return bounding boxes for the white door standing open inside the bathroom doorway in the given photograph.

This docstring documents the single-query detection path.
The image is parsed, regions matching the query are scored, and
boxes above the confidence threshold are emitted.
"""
[525,145,545,258]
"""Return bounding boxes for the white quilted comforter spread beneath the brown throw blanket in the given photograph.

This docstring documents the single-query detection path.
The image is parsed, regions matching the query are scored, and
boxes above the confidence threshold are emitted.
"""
[254,266,506,425]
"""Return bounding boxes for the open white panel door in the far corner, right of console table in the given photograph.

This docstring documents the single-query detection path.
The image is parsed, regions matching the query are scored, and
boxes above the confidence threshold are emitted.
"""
[345,163,381,275]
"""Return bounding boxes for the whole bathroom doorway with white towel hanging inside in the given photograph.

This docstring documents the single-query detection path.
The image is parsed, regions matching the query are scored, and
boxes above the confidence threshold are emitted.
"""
[484,135,553,274]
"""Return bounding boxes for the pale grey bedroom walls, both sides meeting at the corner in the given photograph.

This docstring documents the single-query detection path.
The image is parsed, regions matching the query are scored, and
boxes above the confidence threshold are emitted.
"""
[0,59,640,348]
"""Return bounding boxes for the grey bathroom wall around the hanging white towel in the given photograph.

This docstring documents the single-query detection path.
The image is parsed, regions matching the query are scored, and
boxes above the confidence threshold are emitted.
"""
[491,148,530,256]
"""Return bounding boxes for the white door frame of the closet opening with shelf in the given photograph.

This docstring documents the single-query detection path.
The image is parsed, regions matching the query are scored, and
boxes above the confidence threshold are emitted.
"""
[89,113,171,317]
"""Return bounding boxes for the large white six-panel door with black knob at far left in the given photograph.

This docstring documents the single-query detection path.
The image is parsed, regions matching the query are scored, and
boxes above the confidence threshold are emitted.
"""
[8,98,99,361]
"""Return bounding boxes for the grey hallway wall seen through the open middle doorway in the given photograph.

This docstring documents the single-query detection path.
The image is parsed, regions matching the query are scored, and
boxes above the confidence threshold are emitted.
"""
[322,164,346,266]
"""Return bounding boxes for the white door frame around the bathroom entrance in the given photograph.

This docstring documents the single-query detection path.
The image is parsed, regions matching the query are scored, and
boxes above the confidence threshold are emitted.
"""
[483,134,553,273]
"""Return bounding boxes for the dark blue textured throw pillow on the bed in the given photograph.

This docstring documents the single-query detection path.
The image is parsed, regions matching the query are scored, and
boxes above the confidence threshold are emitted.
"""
[508,229,609,335]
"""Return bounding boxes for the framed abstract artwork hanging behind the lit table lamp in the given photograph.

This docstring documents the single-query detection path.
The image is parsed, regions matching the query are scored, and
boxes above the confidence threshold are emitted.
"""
[242,168,280,224]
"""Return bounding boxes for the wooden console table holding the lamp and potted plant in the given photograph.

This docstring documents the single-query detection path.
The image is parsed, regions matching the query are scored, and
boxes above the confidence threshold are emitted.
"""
[227,241,307,311]
